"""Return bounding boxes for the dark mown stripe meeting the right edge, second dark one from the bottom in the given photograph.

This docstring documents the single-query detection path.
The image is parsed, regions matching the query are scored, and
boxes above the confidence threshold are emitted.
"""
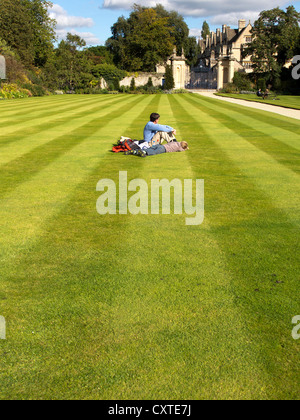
[184,95,300,173]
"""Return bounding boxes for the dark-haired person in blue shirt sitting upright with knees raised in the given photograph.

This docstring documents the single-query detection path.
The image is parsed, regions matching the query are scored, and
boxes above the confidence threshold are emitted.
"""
[144,113,176,146]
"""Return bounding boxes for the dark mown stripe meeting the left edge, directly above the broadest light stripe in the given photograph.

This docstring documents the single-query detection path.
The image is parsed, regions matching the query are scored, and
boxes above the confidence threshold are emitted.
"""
[0,97,145,198]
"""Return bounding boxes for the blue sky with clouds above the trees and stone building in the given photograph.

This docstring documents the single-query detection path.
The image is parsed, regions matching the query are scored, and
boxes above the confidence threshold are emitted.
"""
[50,0,300,46]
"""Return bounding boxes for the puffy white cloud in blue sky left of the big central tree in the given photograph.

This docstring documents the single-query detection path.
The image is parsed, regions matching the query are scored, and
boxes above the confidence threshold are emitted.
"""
[48,4,99,45]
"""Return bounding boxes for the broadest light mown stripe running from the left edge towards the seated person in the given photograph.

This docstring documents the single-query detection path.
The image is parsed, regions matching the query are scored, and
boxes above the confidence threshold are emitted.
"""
[0,96,152,263]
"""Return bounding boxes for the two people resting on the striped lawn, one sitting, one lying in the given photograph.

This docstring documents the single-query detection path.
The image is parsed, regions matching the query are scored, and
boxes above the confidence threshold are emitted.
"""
[125,113,188,157]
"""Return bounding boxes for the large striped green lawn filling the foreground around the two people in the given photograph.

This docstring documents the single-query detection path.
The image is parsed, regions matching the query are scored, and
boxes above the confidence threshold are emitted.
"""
[0,94,300,400]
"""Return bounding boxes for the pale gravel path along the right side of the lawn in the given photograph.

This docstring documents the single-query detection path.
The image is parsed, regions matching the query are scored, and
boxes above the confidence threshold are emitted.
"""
[190,90,300,120]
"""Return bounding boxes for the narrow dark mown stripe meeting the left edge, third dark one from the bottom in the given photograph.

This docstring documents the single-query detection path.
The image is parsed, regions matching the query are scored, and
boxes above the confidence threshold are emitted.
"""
[0,96,132,148]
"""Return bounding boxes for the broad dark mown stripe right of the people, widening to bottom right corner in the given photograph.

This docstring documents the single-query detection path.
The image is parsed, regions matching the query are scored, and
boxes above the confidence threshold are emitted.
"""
[171,93,300,398]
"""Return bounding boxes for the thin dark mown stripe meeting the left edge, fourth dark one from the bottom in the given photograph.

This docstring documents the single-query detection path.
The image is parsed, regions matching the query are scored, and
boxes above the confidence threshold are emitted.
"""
[0,94,115,129]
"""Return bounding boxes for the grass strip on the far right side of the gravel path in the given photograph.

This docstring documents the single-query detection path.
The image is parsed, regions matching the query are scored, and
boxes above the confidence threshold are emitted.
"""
[217,93,300,109]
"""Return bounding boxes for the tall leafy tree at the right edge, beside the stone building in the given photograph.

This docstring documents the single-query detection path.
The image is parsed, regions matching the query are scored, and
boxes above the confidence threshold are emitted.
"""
[243,6,300,84]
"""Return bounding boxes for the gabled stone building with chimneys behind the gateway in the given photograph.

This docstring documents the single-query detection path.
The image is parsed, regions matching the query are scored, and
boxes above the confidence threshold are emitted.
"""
[190,19,252,89]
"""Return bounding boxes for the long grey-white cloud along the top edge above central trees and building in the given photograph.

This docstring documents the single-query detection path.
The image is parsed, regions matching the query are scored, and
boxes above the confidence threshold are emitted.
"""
[103,0,286,18]
